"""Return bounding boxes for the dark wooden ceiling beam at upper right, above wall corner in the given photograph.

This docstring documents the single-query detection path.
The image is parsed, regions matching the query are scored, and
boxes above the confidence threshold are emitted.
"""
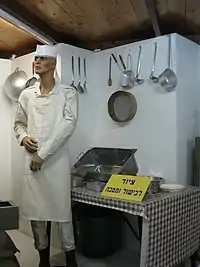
[145,0,161,36]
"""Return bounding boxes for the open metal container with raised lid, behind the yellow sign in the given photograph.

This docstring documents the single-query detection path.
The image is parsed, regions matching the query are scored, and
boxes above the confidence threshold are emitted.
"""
[73,147,138,181]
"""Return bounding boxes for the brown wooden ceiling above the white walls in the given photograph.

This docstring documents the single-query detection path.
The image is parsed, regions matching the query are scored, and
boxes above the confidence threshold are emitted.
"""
[0,0,200,57]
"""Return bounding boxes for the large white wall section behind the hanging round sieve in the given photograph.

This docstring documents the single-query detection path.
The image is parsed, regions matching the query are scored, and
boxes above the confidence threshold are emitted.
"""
[90,36,177,182]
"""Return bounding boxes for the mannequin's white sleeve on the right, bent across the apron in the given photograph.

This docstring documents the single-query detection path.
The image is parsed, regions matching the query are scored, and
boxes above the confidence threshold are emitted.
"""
[38,88,78,160]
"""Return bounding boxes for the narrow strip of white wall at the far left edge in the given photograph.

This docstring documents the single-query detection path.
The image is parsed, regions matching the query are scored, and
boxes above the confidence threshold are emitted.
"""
[0,59,12,200]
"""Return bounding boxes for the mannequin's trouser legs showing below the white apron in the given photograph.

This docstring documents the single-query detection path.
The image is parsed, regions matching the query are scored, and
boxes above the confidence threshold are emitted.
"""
[31,221,75,251]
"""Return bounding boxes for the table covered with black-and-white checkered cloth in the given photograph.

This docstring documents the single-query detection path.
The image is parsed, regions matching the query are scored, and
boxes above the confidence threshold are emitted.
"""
[72,187,200,267]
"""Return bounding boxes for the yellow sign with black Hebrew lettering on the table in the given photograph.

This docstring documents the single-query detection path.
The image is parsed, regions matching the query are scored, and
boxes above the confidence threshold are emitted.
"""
[101,175,152,202]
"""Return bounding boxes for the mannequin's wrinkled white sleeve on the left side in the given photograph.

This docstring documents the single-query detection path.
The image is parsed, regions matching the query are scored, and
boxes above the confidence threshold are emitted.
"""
[14,93,28,145]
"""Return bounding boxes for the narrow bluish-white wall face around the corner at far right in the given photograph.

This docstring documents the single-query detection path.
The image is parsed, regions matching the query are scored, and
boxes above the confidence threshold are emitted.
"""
[176,35,200,184]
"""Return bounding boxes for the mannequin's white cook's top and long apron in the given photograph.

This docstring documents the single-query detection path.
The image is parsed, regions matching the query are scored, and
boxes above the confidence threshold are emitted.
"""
[15,82,77,222]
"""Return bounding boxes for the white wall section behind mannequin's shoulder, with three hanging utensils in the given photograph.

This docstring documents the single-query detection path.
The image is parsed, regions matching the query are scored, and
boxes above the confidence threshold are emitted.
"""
[55,44,97,164]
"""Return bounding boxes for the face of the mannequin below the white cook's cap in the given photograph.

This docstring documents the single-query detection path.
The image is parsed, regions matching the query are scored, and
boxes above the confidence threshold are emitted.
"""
[34,56,56,76]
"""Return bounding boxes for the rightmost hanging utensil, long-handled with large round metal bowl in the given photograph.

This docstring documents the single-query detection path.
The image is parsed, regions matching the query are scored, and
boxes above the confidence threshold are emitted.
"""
[158,34,178,92]
